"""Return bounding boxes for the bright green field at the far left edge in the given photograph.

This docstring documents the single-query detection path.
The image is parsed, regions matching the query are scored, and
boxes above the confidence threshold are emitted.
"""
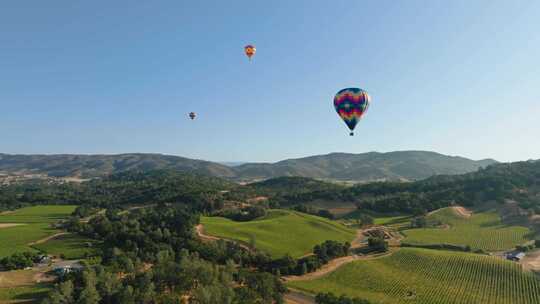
[0,206,75,257]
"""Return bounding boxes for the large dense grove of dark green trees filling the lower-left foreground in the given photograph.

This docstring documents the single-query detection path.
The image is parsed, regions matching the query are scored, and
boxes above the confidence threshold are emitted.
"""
[46,203,286,304]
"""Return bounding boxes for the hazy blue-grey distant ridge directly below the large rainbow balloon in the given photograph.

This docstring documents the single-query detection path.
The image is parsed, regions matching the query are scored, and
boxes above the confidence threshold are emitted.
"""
[235,151,497,181]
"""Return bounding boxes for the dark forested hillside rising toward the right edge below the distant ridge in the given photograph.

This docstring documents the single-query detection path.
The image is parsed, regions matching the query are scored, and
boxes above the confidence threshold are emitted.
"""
[238,161,540,215]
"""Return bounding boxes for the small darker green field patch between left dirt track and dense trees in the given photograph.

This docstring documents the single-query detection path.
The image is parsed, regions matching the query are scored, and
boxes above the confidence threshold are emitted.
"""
[32,234,99,260]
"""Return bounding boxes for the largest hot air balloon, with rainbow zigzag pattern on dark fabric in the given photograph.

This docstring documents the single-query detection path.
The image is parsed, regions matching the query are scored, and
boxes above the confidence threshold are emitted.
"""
[334,88,371,136]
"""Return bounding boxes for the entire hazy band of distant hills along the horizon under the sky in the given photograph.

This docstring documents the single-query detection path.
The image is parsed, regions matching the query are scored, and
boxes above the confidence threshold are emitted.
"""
[0,151,496,182]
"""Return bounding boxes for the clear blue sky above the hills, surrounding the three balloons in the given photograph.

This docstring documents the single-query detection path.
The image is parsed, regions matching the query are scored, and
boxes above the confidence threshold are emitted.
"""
[0,0,540,161]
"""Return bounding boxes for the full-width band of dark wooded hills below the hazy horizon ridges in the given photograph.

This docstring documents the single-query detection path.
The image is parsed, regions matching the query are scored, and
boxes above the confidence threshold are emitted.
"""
[5,161,540,215]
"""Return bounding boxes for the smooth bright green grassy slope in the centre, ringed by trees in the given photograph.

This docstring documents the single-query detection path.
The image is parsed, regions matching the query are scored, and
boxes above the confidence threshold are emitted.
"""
[201,210,356,257]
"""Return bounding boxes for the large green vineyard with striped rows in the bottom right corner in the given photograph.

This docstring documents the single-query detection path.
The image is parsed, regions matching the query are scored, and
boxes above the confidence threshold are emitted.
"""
[288,248,540,304]
